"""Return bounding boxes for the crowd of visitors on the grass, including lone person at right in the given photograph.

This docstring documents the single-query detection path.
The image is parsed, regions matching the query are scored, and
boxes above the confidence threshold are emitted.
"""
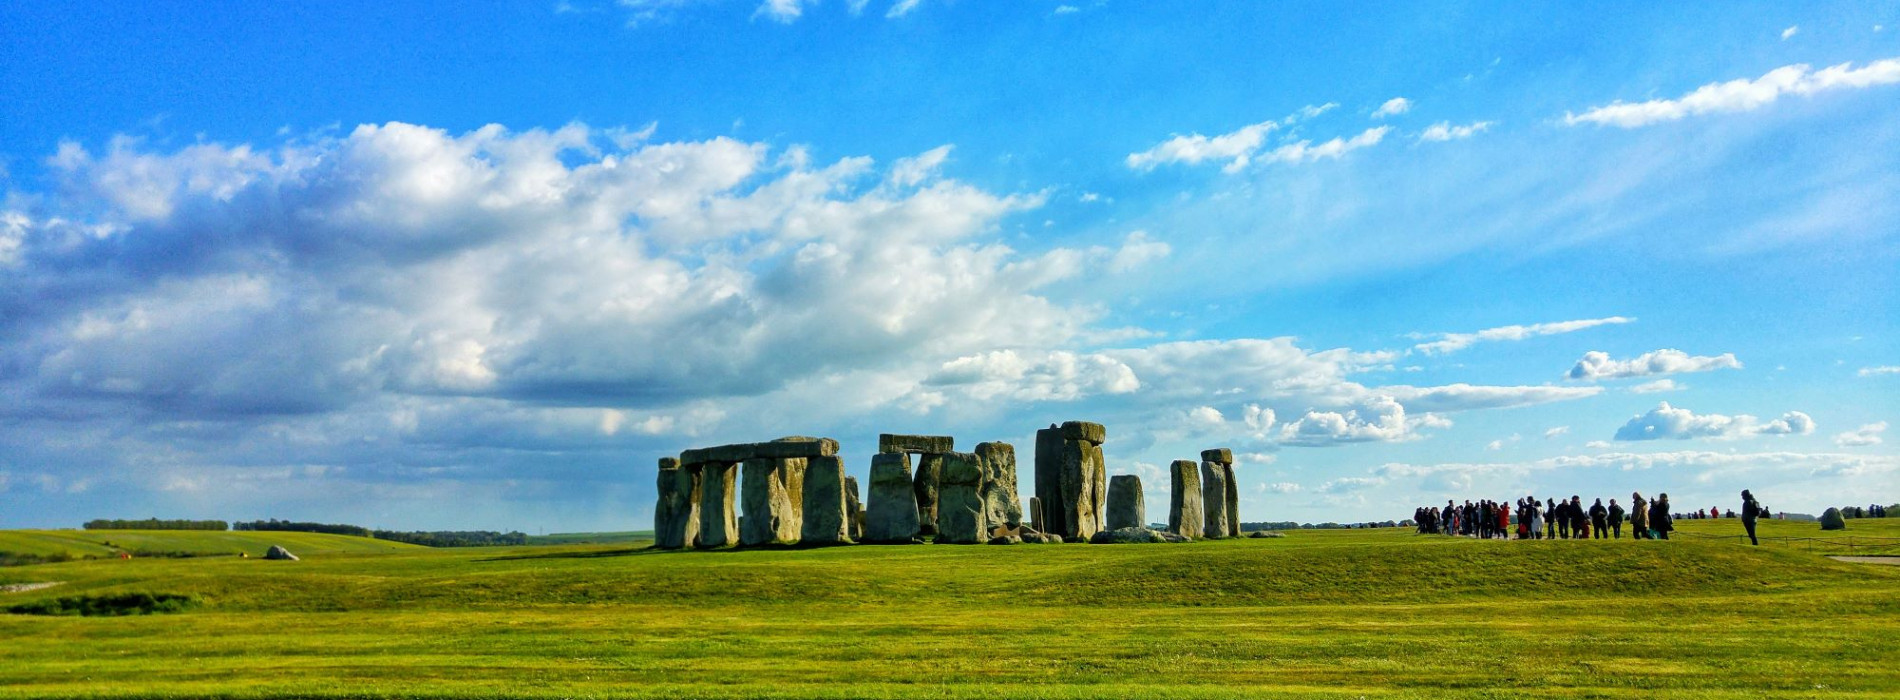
[1412,491,1767,544]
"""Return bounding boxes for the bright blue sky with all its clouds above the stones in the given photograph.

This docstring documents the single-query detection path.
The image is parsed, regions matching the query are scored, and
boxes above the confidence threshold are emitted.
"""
[0,0,1900,531]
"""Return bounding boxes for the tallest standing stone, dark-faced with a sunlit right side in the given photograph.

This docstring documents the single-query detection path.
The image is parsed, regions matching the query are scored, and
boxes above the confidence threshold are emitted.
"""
[1036,420,1108,540]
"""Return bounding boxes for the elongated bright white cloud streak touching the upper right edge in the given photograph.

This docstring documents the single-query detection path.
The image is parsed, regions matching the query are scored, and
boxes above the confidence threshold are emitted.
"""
[1564,59,1900,129]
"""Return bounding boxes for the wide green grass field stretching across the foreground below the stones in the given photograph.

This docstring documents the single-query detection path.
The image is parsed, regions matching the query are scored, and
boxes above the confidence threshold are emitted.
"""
[0,519,1900,698]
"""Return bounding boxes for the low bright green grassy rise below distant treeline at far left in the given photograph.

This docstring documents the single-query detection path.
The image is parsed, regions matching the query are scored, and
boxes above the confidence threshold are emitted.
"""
[0,531,424,559]
